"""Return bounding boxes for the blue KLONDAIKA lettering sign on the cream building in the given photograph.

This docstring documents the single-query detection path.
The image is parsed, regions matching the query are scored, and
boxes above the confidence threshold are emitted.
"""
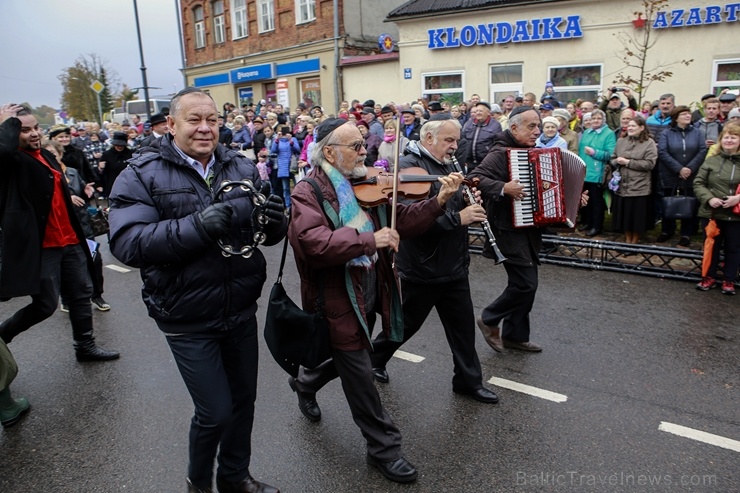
[429,15,583,50]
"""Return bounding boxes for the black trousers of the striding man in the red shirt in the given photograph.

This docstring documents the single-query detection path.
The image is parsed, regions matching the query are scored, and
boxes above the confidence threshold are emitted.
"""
[0,245,93,344]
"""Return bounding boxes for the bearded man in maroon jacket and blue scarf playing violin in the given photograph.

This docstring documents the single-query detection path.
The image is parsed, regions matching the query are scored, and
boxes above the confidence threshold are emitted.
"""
[288,119,463,483]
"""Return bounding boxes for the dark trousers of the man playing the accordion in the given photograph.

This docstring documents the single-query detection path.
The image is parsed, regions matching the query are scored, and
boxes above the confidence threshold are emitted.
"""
[481,262,538,342]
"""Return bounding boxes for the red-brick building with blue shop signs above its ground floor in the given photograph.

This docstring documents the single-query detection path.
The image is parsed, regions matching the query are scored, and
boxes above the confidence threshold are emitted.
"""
[180,0,410,112]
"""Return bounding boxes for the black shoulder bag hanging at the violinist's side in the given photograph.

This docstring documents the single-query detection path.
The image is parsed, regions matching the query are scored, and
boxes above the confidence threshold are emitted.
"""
[264,215,331,378]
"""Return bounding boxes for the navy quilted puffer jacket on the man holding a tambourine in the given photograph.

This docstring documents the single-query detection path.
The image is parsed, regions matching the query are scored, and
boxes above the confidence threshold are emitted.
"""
[109,135,287,334]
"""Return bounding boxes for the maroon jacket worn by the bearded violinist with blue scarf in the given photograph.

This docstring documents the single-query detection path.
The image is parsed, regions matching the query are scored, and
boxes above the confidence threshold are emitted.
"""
[288,168,444,351]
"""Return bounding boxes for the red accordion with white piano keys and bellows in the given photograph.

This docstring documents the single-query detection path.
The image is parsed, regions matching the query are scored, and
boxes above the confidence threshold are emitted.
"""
[508,148,586,228]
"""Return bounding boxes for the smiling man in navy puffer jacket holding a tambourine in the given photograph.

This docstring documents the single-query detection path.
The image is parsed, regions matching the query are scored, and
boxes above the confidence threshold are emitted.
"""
[110,88,287,493]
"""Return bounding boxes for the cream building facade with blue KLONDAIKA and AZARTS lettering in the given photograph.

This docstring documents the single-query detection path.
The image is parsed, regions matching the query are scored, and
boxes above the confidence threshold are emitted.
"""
[344,0,740,104]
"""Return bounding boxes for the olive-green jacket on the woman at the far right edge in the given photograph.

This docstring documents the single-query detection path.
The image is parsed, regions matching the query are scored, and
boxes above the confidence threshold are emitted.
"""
[694,152,740,221]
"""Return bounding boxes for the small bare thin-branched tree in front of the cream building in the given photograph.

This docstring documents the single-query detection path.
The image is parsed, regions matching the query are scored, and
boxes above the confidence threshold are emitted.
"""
[613,0,694,101]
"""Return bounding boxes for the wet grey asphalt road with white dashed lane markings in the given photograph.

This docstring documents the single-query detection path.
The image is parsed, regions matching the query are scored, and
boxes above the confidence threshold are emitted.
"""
[0,237,740,493]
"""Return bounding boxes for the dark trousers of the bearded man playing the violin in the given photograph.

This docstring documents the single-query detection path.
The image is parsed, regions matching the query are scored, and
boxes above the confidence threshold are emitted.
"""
[296,338,401,462]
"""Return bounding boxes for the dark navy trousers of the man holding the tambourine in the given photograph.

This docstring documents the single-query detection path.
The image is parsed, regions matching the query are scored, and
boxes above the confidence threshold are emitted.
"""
[167,317,258,488]
